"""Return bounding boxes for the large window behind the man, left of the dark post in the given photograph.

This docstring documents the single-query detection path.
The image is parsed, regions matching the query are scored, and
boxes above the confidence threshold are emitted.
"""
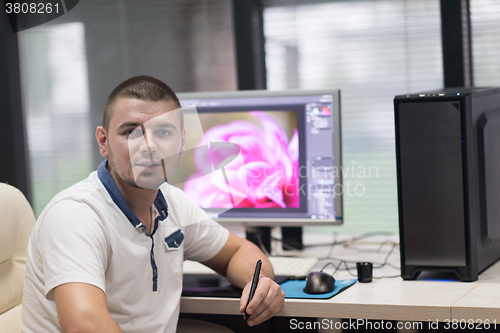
[18,0,237,216]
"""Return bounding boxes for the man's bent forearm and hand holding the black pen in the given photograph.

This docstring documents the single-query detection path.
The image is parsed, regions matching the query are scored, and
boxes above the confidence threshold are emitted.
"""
[204,233,285,326]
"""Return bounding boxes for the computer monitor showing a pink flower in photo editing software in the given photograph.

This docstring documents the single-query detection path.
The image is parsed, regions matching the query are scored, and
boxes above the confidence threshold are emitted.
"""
[173,90,342,226]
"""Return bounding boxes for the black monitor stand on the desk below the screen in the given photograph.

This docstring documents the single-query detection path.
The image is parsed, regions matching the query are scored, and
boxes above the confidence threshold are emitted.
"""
[245,227,304,253]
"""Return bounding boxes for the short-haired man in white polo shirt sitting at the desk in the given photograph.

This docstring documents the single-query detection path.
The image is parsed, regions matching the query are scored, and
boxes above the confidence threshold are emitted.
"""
[21,76,284,332]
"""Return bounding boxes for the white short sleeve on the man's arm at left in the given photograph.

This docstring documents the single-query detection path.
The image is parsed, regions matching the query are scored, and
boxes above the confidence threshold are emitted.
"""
[38,200,109,298]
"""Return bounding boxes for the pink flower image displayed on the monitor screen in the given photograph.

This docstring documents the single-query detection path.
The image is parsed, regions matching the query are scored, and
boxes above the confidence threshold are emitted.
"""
[184,111,300,208]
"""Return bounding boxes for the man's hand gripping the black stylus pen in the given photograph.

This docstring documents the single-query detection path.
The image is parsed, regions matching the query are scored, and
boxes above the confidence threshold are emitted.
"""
[240,277,285,326]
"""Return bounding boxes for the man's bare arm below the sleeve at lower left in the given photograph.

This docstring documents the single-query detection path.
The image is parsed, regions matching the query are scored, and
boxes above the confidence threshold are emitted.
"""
[54,283,122,333]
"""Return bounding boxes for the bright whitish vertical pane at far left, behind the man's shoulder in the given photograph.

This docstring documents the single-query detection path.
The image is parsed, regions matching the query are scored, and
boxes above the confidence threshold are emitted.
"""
[20,23,92,215]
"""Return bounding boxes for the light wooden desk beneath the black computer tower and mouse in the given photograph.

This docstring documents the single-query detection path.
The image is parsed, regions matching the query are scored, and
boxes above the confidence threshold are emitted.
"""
[180,232,500,323]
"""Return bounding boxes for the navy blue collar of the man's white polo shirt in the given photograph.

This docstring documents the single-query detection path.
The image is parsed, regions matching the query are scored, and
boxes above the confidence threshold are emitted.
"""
[97,159,168,236]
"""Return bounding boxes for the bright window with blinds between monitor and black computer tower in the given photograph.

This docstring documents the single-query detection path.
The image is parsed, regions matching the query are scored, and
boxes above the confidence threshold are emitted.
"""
[264,0,443,232]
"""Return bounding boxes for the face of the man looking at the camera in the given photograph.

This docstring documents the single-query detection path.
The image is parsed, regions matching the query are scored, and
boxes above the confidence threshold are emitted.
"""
[103,98,185,189]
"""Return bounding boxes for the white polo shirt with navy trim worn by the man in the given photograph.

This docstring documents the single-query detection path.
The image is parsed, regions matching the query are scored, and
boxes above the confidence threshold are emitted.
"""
[21,161,229,333]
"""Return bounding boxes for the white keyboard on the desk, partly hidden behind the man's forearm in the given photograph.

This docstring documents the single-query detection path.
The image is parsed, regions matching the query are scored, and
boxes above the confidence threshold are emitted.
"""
[183,257,318,276]
